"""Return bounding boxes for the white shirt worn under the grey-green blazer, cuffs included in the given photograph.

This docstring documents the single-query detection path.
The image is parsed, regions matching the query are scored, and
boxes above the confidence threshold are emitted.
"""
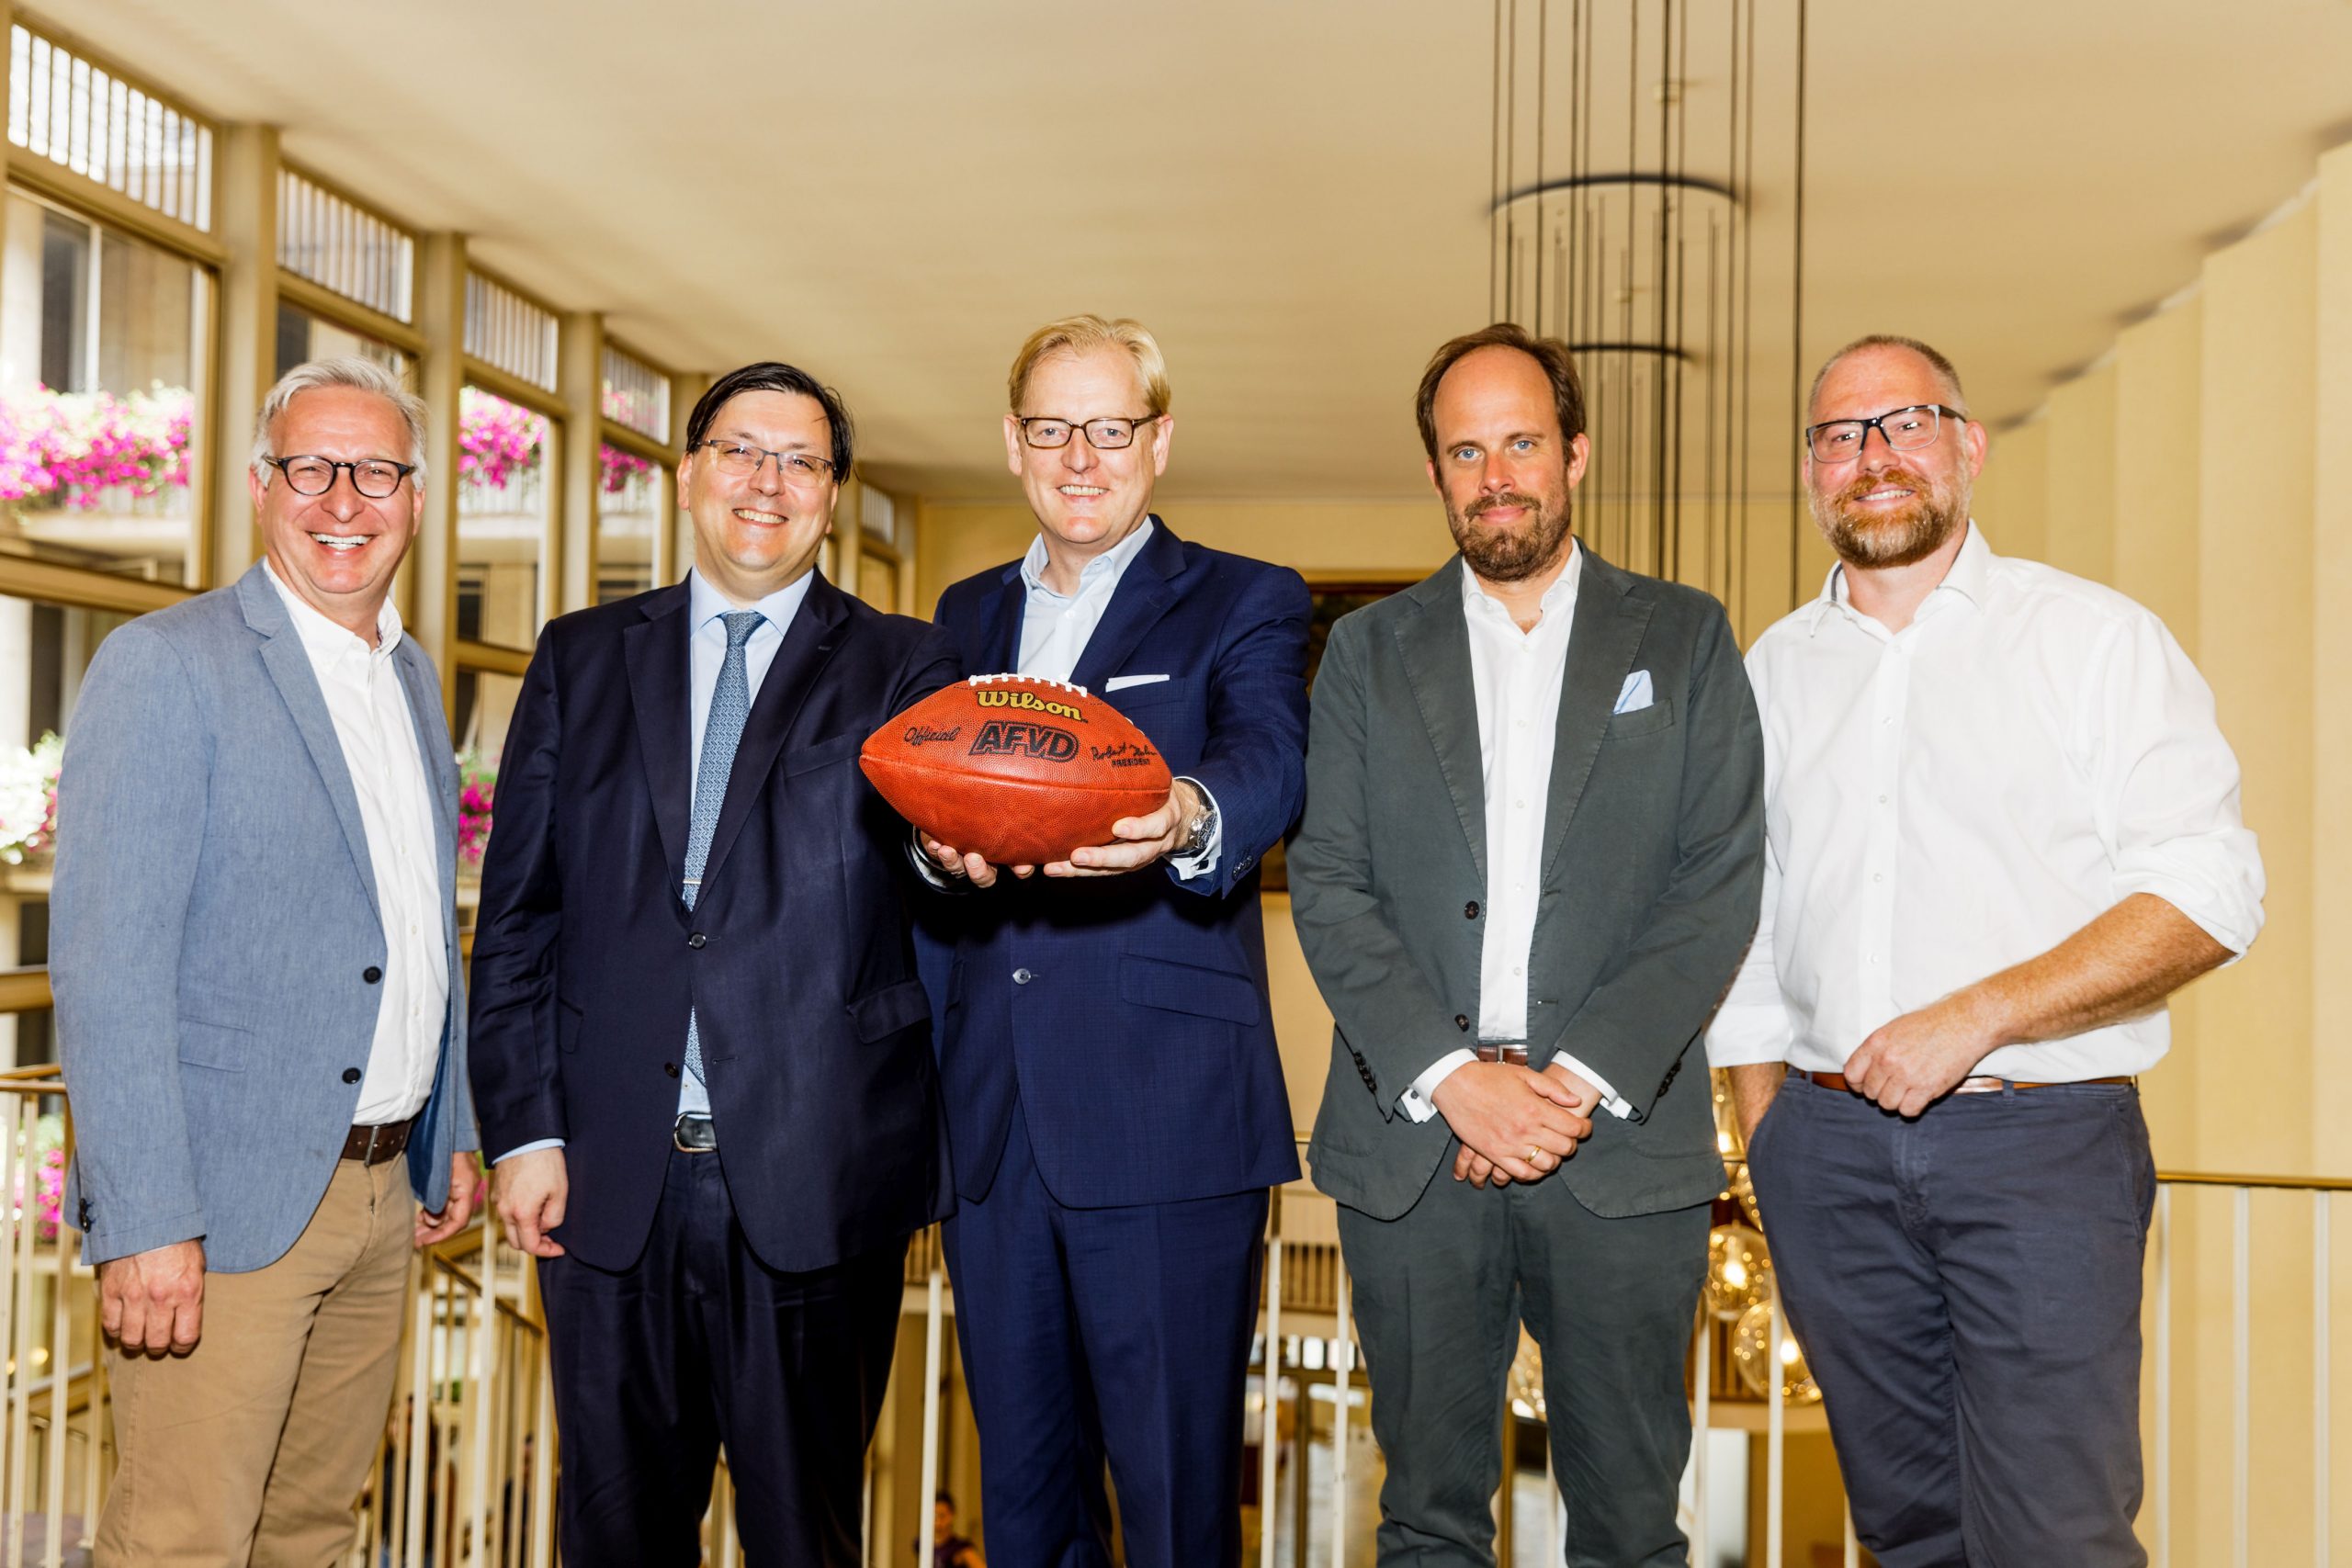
[1397,543,1633,1122]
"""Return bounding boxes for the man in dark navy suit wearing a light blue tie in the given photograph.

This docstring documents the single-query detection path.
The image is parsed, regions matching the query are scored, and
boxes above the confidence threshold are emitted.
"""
[473,365,955,1568]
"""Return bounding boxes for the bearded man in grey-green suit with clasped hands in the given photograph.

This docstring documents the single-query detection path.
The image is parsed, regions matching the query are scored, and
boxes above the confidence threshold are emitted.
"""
[1291,324,1764,1568]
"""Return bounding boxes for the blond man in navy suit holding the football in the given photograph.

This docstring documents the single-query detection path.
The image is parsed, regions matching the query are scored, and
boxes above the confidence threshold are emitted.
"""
[922,315,1307,1568]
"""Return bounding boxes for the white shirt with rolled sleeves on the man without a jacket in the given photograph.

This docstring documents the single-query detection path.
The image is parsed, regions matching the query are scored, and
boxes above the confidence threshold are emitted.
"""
[1708,522,2263,1081]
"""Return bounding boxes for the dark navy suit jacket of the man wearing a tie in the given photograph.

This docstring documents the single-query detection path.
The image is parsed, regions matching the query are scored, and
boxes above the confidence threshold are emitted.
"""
[473,579,955,1269]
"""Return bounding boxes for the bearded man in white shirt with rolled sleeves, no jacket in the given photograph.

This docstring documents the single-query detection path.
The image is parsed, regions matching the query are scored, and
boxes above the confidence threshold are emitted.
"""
[1708,336,2263,1568]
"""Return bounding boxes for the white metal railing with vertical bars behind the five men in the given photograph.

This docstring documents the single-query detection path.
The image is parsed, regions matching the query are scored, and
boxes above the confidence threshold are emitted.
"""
[0,1069,2352,1568]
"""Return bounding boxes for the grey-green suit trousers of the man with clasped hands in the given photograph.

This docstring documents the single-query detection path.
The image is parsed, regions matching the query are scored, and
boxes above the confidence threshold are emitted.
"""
[1339,1156,1708,1568]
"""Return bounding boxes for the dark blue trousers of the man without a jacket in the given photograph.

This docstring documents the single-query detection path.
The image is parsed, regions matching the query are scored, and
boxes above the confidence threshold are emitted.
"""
[1747,1077,2157,1568]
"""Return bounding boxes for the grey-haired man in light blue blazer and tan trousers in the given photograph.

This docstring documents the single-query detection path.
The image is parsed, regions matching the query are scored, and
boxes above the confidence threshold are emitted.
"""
[51,360,478,1565]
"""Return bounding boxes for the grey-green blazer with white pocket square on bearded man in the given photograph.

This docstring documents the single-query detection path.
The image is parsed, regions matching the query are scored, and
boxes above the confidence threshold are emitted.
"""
[1289,550,1764,1220]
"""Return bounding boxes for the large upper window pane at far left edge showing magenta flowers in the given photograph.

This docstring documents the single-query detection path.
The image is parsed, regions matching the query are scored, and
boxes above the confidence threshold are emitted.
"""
[0,190,211,583]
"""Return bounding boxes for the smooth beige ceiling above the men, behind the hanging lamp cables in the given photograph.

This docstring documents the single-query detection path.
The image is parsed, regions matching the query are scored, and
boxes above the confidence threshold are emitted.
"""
[35,0,2352,499]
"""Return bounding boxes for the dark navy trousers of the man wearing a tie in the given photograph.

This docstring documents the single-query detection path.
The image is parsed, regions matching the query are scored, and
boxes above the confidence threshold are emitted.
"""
[538,1152,906,1568]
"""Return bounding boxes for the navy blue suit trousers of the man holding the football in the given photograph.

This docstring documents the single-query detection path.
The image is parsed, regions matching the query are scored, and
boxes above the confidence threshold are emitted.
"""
[944,1107,1265,1568]
